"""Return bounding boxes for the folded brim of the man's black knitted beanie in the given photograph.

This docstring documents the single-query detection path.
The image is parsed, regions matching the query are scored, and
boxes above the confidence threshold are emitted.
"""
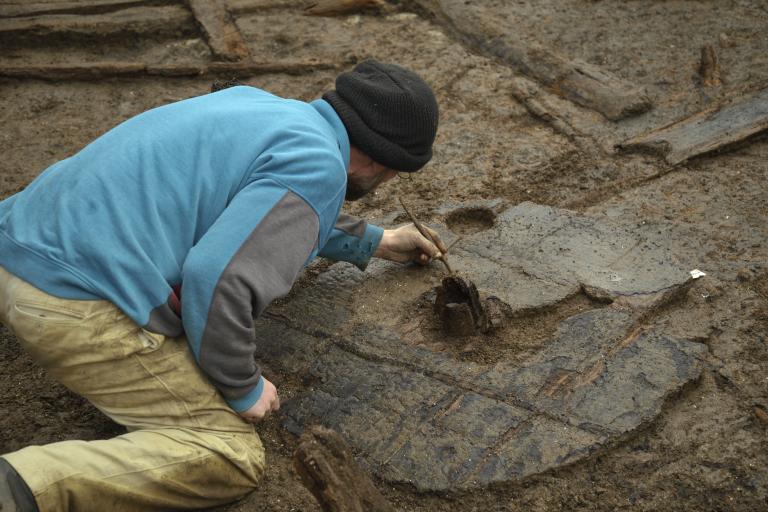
[323,90,432,172]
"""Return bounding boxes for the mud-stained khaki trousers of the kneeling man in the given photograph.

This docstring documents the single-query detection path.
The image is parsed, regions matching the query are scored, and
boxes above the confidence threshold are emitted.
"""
[0,267,264,511]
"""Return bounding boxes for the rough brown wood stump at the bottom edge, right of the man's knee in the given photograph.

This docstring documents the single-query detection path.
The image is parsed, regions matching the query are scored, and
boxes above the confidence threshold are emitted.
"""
[293,426,395,512]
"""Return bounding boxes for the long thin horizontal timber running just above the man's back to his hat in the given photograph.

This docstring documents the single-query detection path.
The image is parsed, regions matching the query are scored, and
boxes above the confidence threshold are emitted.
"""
[0,60,342,80]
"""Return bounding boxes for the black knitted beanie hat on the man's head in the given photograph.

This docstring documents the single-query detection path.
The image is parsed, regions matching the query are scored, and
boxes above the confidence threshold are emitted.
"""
[323,59,438,171]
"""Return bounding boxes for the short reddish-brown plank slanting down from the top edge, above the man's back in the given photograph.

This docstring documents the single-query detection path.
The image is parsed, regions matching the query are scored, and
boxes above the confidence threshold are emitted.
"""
[187,0,251,61]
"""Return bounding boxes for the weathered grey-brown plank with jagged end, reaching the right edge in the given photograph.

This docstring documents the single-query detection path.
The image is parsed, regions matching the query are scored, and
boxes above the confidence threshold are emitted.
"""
[617,88,768,165]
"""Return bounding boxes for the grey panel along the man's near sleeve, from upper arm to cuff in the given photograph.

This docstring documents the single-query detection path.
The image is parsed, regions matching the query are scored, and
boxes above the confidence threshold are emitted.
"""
[199,192,320,399]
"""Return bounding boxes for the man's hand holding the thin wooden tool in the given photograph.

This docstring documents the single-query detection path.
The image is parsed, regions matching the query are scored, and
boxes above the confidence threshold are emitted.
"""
[373,224,448,265]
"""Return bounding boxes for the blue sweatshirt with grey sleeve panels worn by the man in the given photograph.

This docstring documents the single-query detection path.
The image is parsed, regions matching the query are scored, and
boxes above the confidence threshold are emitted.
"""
[0,87,383,411]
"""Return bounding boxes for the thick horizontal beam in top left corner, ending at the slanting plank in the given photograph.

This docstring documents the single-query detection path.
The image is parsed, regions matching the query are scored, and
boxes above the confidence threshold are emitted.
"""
[0,6,193,37]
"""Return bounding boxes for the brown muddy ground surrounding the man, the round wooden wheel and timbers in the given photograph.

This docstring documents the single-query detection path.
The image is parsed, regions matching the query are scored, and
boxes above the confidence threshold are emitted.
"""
[0,0,768,512]
